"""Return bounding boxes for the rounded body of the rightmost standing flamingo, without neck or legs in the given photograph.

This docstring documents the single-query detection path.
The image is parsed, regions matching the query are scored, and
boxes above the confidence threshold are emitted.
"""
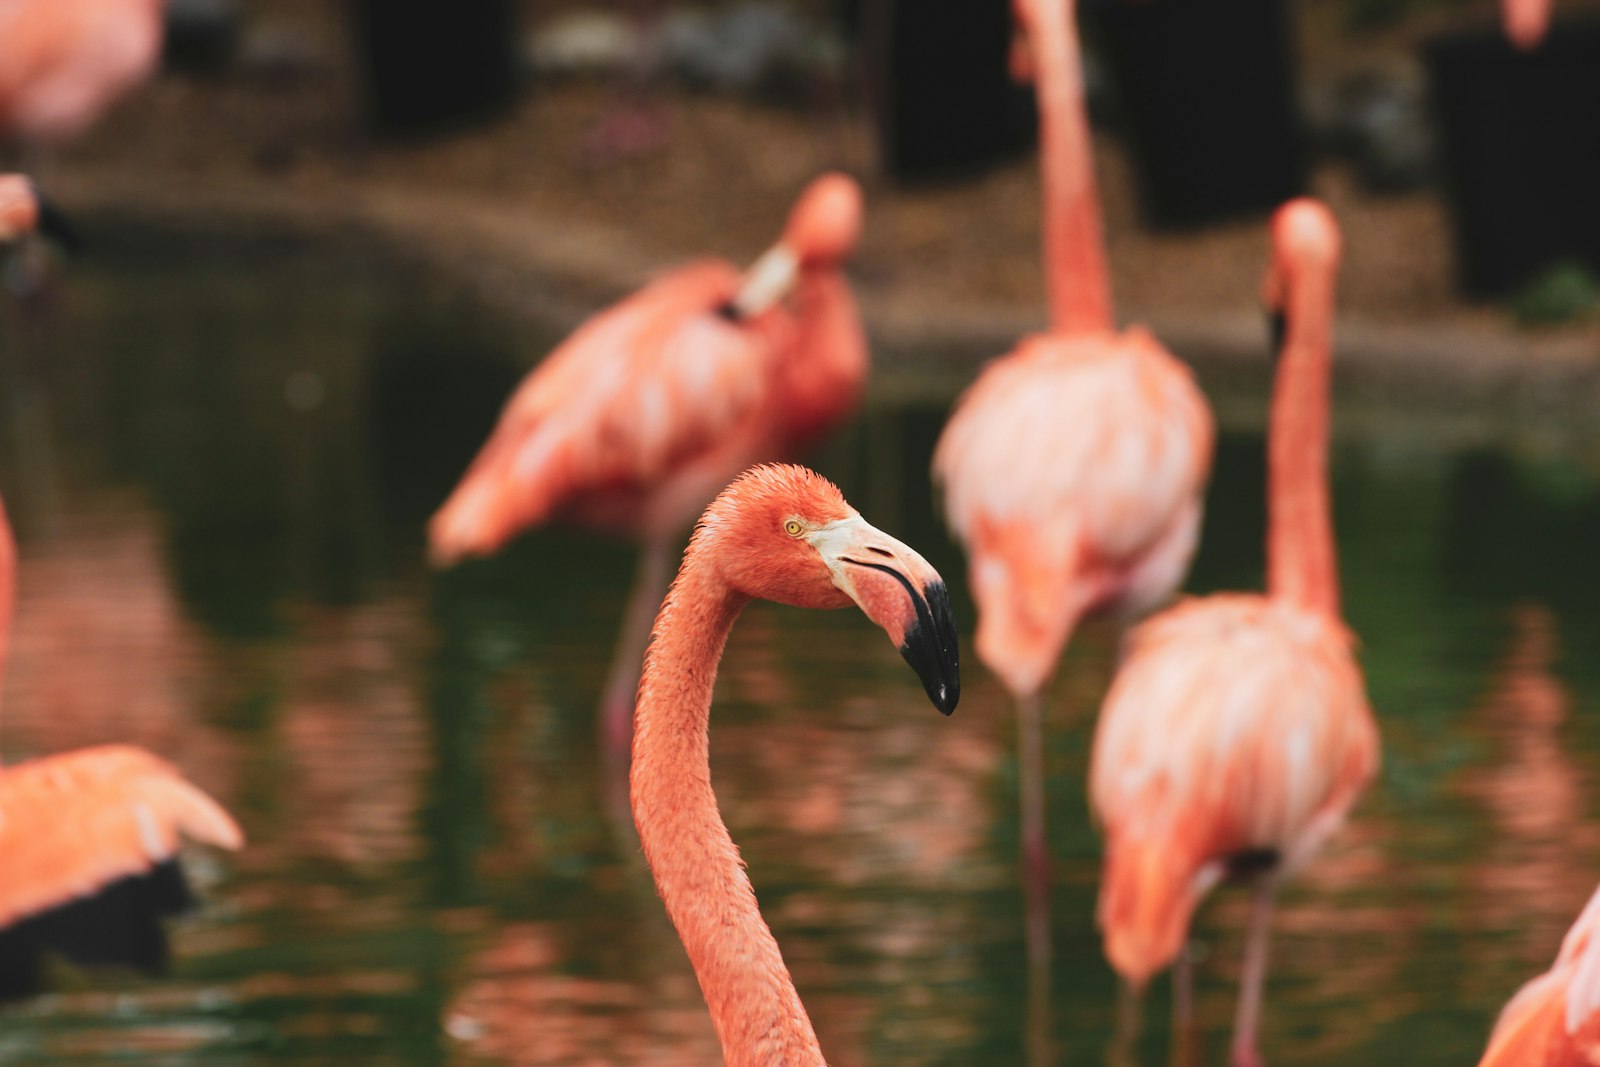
[1090,593,1378,985]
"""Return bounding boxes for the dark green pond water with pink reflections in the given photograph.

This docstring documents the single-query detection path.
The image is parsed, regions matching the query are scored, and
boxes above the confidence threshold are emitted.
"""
[0,227,1600,1067]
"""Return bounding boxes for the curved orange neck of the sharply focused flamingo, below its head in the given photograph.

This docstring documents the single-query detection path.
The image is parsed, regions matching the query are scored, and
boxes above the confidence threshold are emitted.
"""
[630,547,824,1067]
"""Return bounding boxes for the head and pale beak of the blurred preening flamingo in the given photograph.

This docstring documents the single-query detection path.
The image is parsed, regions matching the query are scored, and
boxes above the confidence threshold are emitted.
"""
[733,173,861,317]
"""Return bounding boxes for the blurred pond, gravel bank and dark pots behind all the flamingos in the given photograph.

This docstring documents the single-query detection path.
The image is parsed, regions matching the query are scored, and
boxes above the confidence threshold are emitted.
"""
[9,0,1600,1067]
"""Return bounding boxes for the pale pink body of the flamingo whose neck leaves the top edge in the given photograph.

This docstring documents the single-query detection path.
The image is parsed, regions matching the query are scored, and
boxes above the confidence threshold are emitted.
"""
[933,328,1213,696]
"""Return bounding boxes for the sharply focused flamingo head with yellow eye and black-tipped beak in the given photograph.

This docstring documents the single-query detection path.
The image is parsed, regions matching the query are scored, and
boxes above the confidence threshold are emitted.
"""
[694,464,962,715]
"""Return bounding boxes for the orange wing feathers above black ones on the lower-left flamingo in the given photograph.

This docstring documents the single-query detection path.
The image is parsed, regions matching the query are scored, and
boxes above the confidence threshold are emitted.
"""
[0,745,243,929]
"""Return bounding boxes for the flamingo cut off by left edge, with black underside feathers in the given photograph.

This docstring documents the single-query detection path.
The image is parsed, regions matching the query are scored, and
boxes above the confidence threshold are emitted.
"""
[0,492,243,1000]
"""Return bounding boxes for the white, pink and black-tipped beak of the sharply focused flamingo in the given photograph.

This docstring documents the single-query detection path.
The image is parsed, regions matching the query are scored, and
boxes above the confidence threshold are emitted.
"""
[810,515,962,715]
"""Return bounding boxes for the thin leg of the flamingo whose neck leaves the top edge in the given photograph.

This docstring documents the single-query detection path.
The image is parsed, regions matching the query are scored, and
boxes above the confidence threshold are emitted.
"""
[1016,693,1050,1067]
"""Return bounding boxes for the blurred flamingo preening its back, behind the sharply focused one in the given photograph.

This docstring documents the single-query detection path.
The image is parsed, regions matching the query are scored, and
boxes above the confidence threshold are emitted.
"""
[429,174,867,752]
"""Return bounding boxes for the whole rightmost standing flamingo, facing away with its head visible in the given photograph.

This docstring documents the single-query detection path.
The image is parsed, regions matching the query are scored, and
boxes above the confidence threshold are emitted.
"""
[1090,200,1378,1067]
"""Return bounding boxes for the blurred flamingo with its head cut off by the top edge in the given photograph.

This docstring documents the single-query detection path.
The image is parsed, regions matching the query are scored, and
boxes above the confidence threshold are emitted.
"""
[933,0,1213,1030]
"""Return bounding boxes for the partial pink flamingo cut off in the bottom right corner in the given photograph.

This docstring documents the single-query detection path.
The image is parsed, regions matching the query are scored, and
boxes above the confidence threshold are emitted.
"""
[1478,889,1600,1067]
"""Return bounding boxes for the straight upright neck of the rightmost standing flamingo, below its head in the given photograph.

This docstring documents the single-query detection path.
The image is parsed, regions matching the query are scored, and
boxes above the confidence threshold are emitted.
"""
[1267,267,1339,617]
